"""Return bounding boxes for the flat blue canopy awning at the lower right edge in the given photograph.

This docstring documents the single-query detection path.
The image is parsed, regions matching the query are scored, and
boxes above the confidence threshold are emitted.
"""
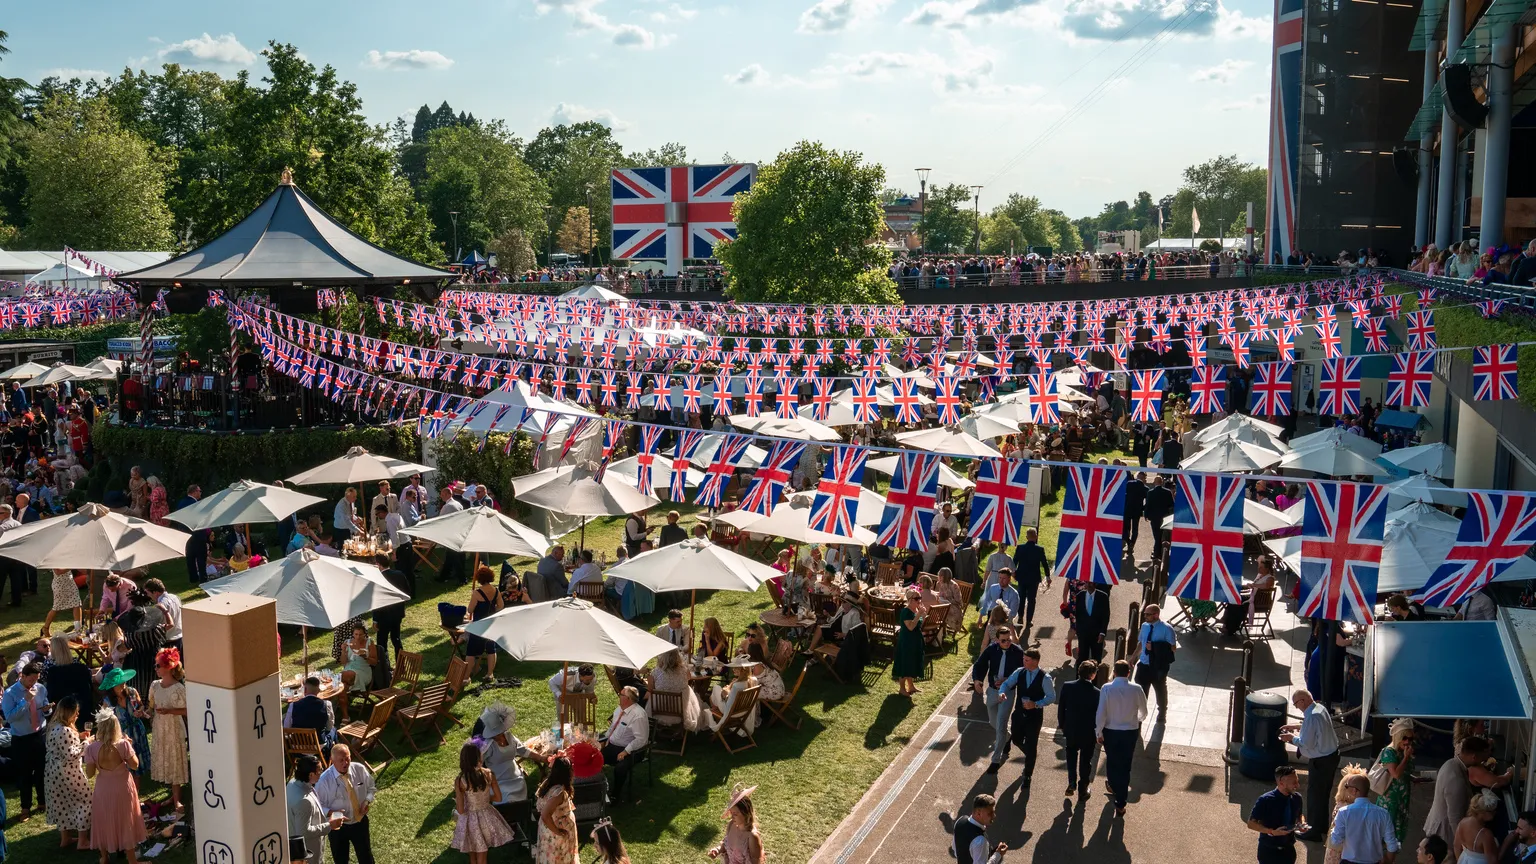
[1366,621,1531,719]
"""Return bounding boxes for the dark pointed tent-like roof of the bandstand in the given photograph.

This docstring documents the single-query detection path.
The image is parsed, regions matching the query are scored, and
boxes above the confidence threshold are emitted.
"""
[118,172,453,287]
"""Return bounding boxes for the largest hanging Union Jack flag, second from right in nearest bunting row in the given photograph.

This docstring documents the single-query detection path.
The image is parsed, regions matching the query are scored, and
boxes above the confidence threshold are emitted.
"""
[1296,480,1387,624]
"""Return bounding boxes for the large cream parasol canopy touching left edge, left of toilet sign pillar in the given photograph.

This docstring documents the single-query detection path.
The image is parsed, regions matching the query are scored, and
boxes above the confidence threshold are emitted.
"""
[0,504,192,570]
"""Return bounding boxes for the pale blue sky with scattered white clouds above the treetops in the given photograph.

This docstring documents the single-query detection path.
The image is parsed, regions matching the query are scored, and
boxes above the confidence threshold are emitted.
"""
[0,0,1272,217]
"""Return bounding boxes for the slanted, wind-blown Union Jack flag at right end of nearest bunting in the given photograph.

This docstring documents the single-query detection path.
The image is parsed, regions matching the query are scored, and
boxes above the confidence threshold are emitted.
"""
[1416,492,1536,606]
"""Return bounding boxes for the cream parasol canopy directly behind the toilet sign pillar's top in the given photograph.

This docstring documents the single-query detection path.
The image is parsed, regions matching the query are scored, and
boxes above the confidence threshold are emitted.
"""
[203,549,410,629]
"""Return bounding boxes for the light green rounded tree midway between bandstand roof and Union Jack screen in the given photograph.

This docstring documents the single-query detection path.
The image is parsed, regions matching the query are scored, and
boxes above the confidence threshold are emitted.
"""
[418,121,550,255]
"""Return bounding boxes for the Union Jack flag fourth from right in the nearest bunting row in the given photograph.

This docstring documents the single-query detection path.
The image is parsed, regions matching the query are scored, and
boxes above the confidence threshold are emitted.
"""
[1056,463,1126,586]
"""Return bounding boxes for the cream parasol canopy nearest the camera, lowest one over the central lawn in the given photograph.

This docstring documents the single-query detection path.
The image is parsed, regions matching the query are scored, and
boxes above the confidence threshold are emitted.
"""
[464,596,677,669]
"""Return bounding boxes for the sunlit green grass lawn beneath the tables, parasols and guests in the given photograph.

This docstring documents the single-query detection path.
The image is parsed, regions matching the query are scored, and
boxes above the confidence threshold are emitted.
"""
[0,485,1081,864]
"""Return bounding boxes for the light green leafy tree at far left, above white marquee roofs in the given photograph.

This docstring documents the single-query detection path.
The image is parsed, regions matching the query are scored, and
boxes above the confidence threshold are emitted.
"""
[26,98,174,249]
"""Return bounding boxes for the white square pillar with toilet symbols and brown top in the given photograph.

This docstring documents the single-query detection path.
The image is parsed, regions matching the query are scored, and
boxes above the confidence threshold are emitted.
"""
[181,593,289,864]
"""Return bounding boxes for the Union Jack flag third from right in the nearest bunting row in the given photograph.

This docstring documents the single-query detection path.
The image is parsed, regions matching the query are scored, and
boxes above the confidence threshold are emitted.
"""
[1167,474,1243,603]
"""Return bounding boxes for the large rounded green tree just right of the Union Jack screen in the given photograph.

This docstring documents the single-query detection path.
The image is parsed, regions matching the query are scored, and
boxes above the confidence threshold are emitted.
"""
[714,141,900,303]
